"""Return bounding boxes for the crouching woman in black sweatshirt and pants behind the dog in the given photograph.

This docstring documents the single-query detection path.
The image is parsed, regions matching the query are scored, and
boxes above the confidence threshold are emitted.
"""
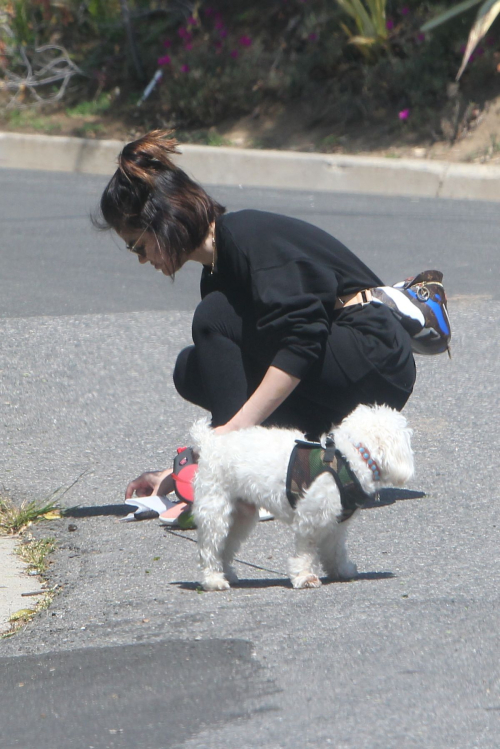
[98,131,415,508]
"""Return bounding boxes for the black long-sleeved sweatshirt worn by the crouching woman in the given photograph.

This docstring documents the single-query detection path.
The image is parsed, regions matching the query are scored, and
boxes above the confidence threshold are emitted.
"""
[201,210,408,380]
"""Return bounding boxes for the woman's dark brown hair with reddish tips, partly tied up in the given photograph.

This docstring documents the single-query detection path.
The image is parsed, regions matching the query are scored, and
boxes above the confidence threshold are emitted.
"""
[92,130,225,274]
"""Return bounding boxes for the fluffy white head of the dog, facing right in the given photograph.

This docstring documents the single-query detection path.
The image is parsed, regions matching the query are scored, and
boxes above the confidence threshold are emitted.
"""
[334,405,414,492]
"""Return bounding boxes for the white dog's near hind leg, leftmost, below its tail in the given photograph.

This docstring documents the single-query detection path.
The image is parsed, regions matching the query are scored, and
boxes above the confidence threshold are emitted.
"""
[193,492,233,590]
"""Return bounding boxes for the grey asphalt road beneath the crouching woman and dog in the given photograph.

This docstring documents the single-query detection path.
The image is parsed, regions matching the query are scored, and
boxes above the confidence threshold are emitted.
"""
[0,171,500,749]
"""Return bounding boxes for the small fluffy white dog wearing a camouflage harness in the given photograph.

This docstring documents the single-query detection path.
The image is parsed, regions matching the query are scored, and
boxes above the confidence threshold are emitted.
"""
[191,406,413,590]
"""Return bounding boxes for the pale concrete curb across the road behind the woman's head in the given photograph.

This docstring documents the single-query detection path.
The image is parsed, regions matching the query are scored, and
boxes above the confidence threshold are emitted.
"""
[0,133,500,202]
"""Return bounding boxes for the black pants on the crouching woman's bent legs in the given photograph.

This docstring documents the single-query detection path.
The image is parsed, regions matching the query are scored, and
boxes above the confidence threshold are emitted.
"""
[174,291,414,438]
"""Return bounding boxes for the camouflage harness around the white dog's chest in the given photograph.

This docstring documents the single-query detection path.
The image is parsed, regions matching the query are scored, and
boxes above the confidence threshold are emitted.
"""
[286,435,374,523]
